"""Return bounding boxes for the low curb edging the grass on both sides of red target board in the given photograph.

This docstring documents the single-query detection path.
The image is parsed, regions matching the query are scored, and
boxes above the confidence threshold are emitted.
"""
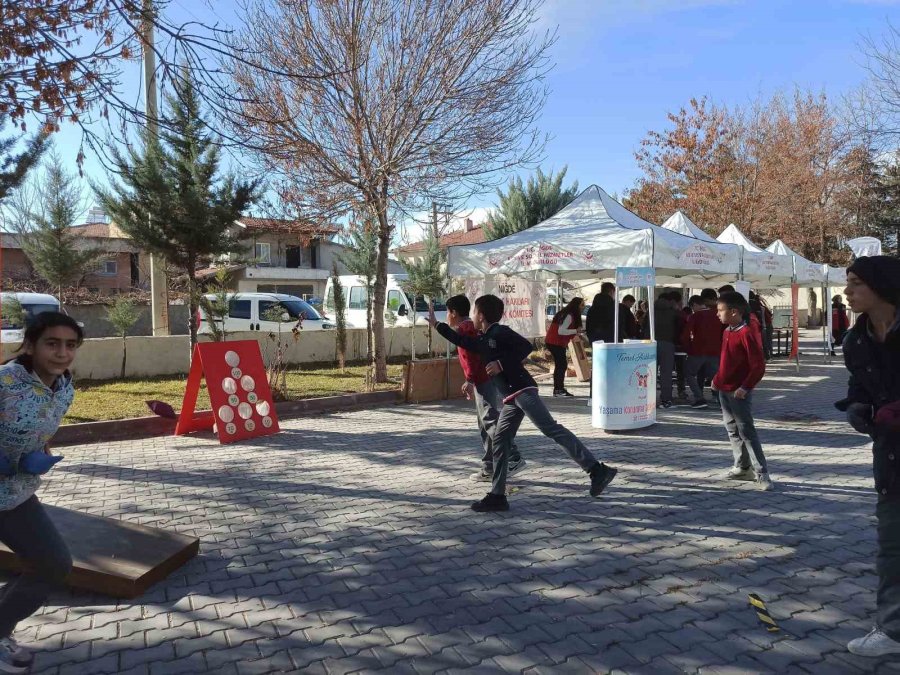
[50,391,402,446]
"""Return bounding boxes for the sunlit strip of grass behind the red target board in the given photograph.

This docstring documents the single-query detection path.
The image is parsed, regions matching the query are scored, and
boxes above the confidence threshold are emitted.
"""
[69,364,403,424]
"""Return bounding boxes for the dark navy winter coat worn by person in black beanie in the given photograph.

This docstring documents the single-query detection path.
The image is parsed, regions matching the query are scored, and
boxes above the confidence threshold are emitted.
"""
[835,313,900,495]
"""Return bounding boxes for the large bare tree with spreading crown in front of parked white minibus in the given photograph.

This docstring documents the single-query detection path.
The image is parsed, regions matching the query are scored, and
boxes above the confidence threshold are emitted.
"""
[231,0,552,382]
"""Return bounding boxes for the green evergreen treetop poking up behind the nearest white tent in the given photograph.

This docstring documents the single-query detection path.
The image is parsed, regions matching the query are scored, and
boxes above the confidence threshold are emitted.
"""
[484,167,578,241]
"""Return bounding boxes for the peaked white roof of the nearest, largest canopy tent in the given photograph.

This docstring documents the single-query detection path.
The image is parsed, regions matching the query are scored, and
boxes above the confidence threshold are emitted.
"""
[447,185,740,284]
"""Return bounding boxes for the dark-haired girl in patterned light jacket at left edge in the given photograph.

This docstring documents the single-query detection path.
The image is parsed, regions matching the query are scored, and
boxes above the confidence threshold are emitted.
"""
[0,312,84,673]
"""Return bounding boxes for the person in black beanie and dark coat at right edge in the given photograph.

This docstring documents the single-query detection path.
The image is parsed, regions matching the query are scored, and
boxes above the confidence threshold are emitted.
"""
[835,256,900,656]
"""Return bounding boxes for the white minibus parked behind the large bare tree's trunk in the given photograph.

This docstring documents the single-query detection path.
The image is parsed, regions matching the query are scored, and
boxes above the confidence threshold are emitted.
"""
[324,274,447,328]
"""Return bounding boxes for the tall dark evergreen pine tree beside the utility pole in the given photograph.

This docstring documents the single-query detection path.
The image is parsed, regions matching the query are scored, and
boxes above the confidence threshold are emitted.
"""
[94,71,260,350]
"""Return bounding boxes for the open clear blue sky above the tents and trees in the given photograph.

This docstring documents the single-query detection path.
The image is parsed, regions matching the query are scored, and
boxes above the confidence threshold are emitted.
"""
[40,0,900,237]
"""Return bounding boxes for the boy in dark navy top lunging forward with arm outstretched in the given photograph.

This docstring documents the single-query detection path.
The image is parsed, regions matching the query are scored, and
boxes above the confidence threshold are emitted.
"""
[429,295,617,511]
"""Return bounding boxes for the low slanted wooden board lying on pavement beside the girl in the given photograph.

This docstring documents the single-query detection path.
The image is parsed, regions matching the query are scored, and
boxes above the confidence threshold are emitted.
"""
[0,504,200,598]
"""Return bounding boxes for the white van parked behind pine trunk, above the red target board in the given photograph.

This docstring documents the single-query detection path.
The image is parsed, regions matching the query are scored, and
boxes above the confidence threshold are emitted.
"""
[197,293,334,334]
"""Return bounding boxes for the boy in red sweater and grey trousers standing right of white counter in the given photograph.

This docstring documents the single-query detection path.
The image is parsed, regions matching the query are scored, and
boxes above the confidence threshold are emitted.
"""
[712,292,773,490]
